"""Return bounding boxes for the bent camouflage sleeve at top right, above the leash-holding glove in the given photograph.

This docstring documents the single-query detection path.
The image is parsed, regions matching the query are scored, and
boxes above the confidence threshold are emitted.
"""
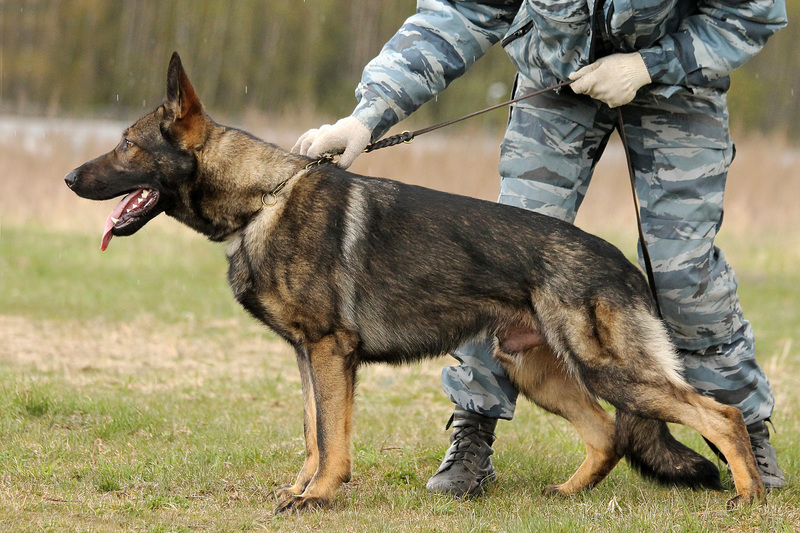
[640,0,787,88]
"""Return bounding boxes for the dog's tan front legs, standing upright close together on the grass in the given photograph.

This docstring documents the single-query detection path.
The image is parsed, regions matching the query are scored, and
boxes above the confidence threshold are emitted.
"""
[275,335,357,513]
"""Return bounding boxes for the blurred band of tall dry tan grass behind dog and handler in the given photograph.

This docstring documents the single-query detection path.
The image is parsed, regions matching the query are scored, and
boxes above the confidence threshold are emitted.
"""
[0,117,800,238]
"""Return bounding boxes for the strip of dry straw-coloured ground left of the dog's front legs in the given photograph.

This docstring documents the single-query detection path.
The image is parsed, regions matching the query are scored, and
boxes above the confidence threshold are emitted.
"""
[0,315,299,386]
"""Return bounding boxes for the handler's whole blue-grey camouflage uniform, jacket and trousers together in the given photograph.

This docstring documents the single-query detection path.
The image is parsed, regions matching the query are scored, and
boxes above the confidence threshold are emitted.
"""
[353,0,786,424]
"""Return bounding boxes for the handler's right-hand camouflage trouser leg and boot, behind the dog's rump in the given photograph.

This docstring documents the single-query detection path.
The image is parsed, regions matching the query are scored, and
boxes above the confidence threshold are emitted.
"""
[623,91,783,488]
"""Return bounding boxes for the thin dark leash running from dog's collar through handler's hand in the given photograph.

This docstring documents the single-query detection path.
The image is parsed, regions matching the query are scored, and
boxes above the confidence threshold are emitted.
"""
[318,81,663,319]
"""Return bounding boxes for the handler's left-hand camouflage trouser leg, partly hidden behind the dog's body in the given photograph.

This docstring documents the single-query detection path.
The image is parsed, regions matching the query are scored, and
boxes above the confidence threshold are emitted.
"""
[442,76,615,420]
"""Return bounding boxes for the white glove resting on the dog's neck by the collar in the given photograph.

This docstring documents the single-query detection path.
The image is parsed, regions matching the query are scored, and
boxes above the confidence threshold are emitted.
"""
[292,117,372,168]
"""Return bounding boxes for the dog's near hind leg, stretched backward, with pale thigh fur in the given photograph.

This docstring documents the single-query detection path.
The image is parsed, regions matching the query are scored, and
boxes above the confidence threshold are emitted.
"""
[570,302,764,506]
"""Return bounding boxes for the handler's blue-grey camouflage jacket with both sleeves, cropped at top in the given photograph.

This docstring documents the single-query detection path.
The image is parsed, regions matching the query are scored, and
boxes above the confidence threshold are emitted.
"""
[353,0,787,139]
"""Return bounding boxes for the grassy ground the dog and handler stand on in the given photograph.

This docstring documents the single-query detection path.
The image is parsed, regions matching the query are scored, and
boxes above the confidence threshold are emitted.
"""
[0,222,800,532]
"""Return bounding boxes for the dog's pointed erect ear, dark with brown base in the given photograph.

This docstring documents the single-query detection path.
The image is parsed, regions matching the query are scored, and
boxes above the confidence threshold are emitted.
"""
[166,52,205,147]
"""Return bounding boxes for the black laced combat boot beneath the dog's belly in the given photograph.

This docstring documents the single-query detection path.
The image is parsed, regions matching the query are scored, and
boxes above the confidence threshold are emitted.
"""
[427,406,497,498]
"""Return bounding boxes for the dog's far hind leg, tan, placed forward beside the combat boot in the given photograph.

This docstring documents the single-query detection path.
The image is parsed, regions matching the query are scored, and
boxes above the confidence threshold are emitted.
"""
[495,345,621,495]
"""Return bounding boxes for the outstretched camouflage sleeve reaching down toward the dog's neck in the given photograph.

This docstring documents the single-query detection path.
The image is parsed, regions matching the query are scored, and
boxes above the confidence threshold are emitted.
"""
[353,0,519,139]
